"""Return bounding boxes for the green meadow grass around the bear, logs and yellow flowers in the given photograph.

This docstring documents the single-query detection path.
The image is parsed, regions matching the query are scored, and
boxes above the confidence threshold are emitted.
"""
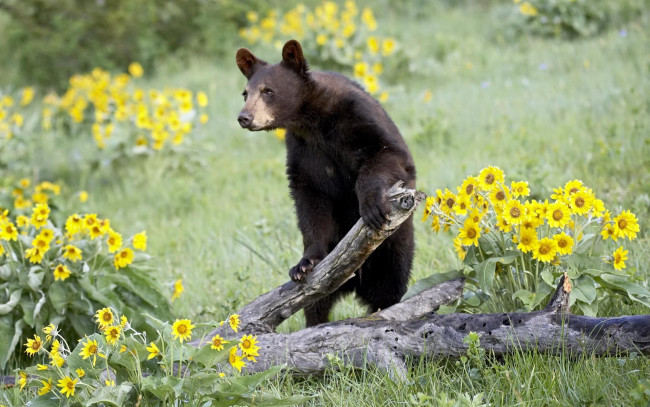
[1,0,650,406]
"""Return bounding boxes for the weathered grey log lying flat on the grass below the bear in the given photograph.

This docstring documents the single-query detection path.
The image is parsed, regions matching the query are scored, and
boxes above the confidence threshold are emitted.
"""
[234,277,650,377]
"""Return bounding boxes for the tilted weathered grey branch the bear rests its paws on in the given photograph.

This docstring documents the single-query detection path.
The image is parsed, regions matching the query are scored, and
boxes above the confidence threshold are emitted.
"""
[193,182,426,345]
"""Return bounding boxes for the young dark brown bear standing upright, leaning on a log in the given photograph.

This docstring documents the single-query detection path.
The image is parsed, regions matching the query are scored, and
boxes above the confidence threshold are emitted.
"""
[236,40,416,326]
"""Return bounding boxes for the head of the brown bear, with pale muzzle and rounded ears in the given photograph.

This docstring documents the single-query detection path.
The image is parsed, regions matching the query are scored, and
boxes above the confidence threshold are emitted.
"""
[236,40,310,131]
